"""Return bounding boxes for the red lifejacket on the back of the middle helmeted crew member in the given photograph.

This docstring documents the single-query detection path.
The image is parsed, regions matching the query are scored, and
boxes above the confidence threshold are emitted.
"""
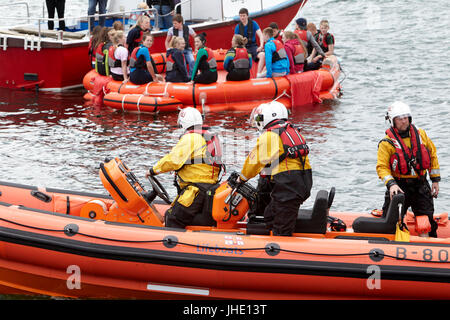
[266,120,309,165]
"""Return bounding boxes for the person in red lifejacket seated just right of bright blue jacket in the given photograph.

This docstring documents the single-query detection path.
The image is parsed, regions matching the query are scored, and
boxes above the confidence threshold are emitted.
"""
[283,31,308,74]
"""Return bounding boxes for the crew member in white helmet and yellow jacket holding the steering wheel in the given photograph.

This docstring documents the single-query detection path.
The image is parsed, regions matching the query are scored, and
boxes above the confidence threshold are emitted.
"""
[147,107,222,228]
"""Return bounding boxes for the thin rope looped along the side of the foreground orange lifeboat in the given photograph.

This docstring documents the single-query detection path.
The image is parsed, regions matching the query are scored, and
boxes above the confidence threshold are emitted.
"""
[0,214,450,263]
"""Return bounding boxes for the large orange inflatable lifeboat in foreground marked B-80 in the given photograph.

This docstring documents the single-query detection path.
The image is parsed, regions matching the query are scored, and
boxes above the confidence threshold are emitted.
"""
[0,158,450,300]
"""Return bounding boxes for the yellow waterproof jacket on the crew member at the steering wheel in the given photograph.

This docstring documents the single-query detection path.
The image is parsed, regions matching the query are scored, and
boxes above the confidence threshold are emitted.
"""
[153,133,219,187]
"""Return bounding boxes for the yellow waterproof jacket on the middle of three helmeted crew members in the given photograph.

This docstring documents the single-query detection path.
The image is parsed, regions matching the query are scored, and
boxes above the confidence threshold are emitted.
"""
[240,131,311,181]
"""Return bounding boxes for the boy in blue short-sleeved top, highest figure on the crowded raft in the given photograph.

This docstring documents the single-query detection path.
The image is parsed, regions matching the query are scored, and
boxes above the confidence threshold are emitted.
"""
[234,8,264,62]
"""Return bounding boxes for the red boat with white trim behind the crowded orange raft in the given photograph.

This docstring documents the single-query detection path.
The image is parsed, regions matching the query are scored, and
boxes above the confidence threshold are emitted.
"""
[0,0,307,91]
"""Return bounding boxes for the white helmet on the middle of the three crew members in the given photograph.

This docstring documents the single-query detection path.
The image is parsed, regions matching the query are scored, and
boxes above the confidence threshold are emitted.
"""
[249,101,288,132]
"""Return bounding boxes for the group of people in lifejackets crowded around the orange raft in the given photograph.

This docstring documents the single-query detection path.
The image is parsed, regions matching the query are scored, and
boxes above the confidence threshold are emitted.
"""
[89,8,334,84]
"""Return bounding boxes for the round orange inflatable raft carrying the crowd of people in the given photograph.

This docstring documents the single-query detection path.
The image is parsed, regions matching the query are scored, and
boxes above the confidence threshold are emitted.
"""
[83,50,341,112]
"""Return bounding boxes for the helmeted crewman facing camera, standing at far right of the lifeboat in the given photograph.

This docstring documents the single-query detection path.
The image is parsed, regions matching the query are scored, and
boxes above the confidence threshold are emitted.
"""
[376,101,441,237]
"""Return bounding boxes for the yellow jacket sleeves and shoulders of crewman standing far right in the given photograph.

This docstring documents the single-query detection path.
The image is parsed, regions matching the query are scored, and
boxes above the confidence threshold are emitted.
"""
[376,128,441,185]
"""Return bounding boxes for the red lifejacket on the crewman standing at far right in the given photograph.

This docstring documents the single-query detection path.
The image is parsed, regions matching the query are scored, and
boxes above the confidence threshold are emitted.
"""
[383,124,431,176]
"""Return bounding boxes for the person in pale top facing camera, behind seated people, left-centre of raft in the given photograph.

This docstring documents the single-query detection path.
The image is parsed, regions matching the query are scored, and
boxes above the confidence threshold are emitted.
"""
[165,14,197,77]
